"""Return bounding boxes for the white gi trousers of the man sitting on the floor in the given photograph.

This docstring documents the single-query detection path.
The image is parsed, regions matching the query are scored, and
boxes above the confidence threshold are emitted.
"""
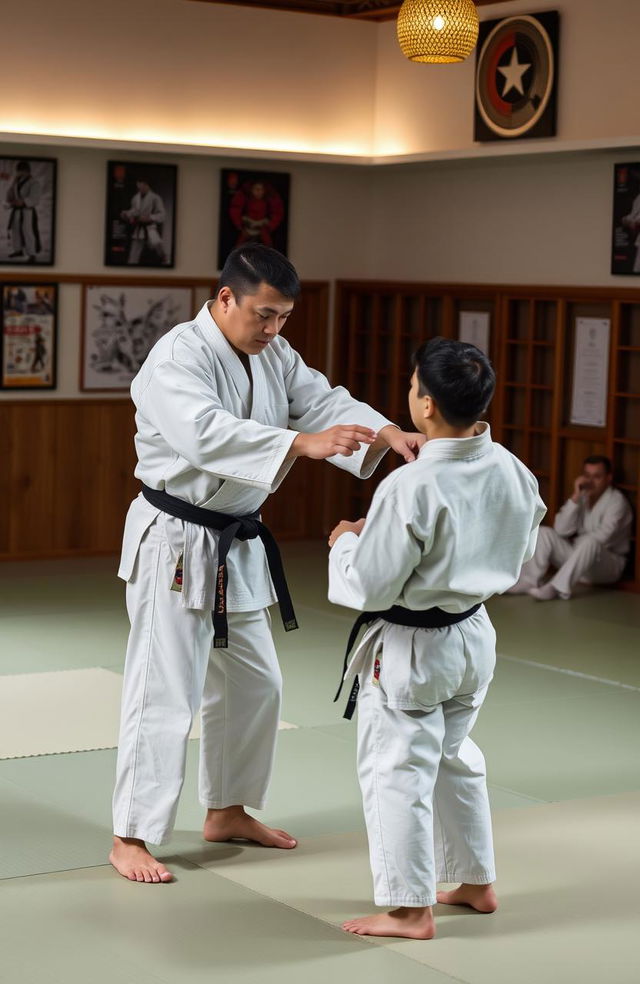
[520,526,625,596]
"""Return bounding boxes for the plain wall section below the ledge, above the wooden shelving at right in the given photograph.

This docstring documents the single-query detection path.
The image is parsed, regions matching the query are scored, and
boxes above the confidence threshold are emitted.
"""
[373,151,640,287]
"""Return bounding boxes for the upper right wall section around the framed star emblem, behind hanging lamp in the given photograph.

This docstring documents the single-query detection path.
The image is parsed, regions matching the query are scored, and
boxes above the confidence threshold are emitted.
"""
[375,0,640,155]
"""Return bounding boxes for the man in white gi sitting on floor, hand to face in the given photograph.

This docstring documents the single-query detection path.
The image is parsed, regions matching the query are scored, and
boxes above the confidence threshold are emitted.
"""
[507,454,632,601]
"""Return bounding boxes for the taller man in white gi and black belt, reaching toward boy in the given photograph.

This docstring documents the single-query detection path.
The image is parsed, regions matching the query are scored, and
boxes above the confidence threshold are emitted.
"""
[110,244,423,882]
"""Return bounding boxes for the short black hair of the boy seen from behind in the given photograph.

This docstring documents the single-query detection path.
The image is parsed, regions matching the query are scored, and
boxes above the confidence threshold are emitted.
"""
[412,337,496,427]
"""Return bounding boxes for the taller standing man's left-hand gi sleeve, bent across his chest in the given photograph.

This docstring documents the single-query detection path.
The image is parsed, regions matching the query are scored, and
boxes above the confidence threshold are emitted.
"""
[136,360,296,492]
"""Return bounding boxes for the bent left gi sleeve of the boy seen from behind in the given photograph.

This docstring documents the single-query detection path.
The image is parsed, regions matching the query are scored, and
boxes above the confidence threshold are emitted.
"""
[329,478,424,611]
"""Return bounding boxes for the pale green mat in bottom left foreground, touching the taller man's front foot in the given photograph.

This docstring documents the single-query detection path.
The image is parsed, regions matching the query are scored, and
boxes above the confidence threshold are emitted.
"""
[0,849,460,984]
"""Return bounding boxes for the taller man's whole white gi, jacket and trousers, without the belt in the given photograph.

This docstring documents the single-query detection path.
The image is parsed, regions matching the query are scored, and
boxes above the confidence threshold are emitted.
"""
[114,305,390,844]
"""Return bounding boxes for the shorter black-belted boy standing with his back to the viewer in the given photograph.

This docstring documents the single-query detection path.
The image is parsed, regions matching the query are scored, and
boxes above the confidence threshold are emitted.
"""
[329,338,545,939]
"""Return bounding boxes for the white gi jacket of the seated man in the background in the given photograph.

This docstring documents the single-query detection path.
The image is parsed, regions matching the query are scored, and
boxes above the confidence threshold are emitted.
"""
[553,488,633,557]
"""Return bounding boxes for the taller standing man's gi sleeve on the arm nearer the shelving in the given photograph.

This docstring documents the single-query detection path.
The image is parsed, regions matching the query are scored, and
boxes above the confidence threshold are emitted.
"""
[283,340,396,478]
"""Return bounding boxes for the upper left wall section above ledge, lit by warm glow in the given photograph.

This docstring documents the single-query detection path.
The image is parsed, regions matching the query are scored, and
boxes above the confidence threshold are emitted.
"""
[0,0,376,154]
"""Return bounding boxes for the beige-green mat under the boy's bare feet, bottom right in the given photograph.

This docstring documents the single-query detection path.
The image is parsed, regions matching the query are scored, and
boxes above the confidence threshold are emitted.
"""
[188,794,640,984]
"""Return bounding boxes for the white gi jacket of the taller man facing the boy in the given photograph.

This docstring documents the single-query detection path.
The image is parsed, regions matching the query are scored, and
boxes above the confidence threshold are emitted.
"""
[118,302,390,611]
